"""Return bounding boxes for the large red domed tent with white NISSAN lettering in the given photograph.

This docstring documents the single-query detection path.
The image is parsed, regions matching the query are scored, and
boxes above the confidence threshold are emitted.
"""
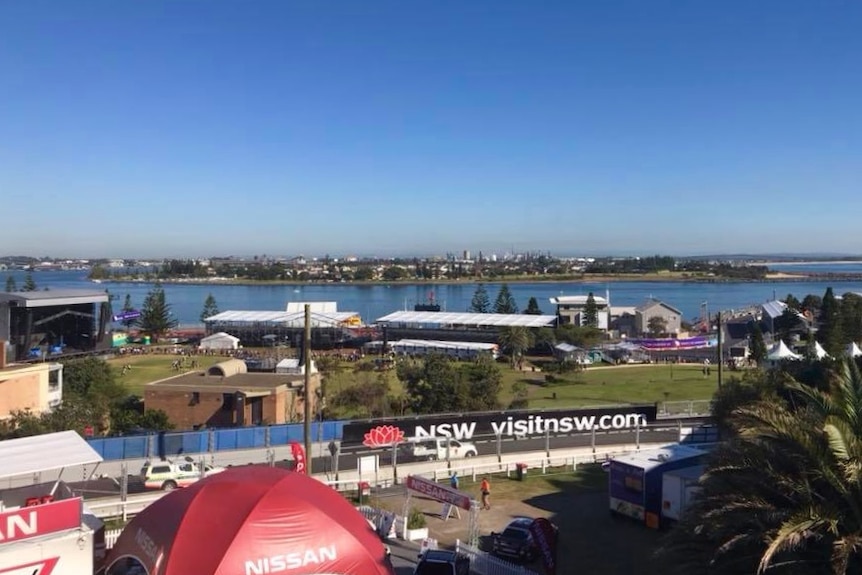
[106,466,394,575]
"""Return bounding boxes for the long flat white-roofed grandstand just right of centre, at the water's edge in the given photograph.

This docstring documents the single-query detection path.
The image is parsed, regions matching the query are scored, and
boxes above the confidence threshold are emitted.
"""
[374,311,557,343]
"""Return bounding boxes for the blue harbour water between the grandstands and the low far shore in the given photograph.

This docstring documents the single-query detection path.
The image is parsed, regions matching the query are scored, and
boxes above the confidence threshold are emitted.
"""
[0,267,862,325]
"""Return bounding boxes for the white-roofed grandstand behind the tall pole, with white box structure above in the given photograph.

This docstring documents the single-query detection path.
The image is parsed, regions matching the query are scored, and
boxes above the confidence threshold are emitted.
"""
[204,302,371,349]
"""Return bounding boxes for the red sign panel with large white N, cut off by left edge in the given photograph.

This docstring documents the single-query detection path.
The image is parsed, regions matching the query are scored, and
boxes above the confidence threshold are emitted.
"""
[0,497,81,544]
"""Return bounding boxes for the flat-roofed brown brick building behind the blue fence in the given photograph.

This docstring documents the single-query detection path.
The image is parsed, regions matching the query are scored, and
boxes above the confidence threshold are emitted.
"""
[144,359,320,429]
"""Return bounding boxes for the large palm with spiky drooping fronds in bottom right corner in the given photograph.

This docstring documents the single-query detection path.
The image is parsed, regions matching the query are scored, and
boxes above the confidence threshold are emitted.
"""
[660,361,862,575]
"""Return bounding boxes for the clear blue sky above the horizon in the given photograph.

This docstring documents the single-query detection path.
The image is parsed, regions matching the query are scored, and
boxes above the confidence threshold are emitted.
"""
[0,0,862,257]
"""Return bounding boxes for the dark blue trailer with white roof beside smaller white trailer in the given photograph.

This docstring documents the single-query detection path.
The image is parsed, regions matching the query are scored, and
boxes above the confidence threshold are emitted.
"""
[608,444,706,529]
